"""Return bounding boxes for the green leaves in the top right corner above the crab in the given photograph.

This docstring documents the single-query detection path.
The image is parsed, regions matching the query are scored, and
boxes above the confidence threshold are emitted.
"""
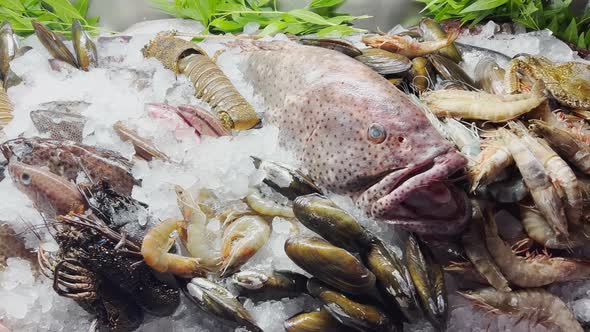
[416,0,590,48]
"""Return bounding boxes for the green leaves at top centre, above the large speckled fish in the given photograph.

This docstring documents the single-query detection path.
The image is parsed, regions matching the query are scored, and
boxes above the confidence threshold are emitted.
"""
[150,0,369,37]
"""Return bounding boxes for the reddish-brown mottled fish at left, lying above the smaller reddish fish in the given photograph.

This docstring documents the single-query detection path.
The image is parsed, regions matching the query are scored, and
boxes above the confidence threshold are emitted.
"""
[0,137,135,194]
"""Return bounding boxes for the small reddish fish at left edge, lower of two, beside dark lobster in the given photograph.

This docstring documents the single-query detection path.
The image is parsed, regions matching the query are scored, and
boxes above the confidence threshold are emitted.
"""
[8,161,84,217]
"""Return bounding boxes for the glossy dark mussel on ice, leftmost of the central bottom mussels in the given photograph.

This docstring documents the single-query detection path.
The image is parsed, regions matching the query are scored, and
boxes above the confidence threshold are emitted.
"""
[183,278,262,332]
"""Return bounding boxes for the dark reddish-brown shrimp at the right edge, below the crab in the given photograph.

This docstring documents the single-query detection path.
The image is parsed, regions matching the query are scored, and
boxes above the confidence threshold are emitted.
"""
[531,120,590,175]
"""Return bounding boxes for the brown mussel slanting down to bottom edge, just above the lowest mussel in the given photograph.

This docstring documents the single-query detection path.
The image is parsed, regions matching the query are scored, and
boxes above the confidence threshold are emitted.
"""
[307,278,393,331]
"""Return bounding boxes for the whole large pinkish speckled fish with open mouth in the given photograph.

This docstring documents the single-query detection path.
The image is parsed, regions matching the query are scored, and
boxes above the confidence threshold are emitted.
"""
[241,42,469,235]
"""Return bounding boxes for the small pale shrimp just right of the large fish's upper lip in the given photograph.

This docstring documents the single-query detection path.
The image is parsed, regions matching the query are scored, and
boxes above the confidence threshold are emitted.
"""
[467,138,514,191]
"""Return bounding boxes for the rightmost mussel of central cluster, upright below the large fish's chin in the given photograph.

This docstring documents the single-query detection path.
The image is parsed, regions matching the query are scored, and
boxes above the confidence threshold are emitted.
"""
[405,235,449,328]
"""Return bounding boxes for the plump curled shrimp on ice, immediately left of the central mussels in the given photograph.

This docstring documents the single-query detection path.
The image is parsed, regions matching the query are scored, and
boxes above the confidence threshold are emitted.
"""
[221,215,272,275]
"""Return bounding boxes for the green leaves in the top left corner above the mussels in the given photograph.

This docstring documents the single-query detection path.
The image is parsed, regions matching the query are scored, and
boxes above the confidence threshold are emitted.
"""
[0,0,99,38]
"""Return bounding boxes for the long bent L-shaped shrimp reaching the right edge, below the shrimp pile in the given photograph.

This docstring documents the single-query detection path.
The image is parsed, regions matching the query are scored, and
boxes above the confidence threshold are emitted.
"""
[484,211,590,287]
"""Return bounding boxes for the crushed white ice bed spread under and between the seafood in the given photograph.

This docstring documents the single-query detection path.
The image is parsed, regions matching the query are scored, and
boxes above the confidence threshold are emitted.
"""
[0,20,590,332]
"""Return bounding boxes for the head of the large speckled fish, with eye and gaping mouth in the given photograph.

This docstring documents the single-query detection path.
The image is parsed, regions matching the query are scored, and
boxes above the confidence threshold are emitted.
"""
[304,83,469,233]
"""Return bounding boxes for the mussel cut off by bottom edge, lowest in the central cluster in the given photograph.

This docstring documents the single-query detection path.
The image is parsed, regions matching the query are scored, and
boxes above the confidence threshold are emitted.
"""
[283,308,356,332]
